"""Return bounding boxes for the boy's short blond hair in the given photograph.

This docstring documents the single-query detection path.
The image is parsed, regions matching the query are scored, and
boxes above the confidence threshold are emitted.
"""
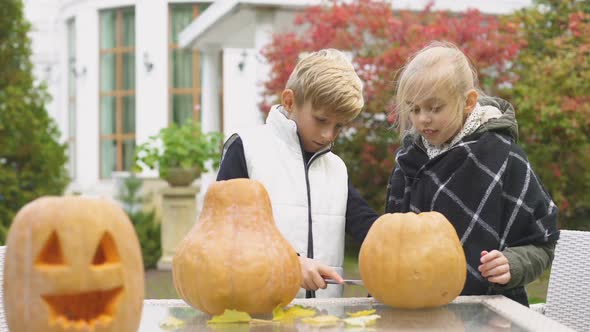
[286,49,365,121]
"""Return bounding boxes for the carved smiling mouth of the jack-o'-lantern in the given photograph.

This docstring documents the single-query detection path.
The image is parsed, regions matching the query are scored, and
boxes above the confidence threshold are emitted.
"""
[41,287,123,328]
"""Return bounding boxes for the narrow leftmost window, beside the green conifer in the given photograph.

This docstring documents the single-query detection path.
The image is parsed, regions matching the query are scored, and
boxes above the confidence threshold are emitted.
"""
[66,19,76,179]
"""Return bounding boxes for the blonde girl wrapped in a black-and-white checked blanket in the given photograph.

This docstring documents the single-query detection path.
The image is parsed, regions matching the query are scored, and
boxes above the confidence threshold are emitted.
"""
[386,42,559,306]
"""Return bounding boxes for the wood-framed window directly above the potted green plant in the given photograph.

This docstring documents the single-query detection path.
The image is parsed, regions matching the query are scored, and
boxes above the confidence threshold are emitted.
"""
[168,3,209,124]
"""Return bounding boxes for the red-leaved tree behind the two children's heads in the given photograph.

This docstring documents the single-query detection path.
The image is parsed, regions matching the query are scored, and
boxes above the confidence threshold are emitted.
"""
[261,0,521,211]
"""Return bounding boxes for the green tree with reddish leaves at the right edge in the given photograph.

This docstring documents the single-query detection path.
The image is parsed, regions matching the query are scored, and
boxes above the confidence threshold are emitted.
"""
[505,0,590,229]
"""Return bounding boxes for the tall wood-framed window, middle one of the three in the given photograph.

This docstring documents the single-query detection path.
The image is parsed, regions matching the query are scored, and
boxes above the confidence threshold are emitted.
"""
[99,7,135,178]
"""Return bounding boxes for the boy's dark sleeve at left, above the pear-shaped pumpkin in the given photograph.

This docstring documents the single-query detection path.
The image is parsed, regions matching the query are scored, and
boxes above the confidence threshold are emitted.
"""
[217,135,250,181]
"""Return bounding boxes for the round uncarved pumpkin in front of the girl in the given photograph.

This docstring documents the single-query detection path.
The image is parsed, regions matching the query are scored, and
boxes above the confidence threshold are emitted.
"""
[359,212,467,309]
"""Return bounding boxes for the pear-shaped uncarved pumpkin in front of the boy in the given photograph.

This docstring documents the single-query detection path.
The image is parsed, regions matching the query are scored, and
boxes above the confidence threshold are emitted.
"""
[172,179,302,315]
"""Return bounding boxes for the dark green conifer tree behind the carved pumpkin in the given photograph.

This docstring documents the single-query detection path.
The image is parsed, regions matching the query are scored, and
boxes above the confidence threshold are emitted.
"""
[0,0,68,243]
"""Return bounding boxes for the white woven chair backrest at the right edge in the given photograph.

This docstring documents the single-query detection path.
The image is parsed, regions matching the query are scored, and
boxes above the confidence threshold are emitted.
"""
[545,230,590,331]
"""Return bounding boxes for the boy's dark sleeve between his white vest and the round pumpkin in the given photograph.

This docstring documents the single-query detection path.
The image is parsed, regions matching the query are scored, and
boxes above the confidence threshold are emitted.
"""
[346,181,379,243]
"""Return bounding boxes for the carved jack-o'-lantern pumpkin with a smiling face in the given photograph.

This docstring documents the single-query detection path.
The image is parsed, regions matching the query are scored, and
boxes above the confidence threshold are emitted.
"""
[3,196,144,332]
